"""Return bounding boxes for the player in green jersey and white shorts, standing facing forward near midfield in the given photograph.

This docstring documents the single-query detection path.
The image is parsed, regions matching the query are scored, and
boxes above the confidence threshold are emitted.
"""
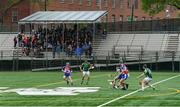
[80,60,94,85]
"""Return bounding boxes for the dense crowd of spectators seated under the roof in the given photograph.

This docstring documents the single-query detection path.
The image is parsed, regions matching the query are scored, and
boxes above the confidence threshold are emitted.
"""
[14,25,93,58]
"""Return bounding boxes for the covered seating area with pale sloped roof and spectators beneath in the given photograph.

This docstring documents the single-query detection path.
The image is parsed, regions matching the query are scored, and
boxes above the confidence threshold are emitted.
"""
[18,11,107,58]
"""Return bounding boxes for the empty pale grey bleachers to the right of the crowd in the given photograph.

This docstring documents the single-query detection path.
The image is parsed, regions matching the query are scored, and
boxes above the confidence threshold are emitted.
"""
[95,34,180,57]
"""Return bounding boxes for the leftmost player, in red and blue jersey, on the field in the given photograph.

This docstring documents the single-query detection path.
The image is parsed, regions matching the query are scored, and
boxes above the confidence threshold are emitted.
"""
[62,63,73,85]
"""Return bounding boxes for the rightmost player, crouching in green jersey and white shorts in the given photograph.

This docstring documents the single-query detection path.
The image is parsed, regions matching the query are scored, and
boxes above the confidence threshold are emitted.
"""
[137,64,155,91]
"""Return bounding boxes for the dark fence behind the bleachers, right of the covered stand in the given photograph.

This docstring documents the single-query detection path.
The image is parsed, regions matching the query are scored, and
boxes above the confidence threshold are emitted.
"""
[107,18,180,32]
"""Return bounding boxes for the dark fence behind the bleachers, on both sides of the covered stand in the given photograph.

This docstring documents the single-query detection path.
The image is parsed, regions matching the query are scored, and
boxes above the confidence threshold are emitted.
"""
[0,18,180,33]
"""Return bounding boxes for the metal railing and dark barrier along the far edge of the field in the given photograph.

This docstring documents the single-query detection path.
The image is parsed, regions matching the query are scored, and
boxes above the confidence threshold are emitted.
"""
[0,49,180,71]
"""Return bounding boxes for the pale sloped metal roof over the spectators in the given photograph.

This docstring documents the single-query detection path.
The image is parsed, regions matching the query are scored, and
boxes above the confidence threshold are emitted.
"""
[18,11,107,24]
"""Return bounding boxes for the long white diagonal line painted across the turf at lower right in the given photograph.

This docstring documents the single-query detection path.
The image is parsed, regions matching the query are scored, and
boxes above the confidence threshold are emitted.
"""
[97,75,180,107]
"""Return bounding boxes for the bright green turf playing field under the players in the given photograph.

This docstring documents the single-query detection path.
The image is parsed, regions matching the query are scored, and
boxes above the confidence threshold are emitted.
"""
[0,72,180,106]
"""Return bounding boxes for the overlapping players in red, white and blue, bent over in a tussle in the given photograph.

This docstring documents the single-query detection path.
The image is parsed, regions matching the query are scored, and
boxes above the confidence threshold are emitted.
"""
[112,64,129,90]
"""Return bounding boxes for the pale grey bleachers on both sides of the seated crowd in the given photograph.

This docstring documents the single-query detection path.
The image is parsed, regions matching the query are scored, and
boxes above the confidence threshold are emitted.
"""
[0,34,180,58]
